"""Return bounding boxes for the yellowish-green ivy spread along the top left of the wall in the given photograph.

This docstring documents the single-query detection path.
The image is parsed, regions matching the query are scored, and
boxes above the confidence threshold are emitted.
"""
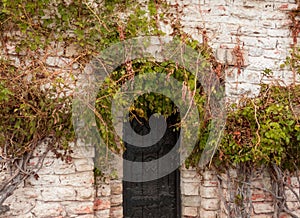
[0,0,162,55]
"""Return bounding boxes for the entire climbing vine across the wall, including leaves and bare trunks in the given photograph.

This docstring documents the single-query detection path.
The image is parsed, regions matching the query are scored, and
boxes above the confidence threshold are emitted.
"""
[0,0,300,217]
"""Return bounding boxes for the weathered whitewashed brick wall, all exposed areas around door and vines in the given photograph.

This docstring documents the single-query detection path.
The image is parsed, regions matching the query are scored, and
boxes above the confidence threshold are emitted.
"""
[0,0,300,218]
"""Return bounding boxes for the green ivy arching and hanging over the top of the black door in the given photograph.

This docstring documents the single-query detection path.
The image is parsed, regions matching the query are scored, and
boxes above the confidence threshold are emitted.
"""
[96,60,206,152]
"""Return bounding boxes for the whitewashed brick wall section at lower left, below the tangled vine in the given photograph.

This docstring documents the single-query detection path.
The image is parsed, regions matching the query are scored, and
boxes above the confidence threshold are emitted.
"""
[0,142,95,218]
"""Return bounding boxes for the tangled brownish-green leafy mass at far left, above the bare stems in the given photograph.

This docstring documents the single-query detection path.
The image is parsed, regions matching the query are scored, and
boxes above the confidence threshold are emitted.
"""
[0,61,74,159]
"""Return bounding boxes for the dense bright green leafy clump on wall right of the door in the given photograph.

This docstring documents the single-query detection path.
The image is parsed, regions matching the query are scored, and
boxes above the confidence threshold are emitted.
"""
[218,86,300,169]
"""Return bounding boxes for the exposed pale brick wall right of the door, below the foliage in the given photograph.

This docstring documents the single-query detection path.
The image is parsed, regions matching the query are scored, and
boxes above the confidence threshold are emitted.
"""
[181,166,300,218]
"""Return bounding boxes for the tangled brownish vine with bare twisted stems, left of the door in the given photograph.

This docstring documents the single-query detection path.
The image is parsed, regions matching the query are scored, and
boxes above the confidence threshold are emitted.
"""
[0,56,74,212]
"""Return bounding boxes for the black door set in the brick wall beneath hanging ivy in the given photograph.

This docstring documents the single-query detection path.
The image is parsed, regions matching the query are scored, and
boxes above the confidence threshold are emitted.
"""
[123,113,181,218]
